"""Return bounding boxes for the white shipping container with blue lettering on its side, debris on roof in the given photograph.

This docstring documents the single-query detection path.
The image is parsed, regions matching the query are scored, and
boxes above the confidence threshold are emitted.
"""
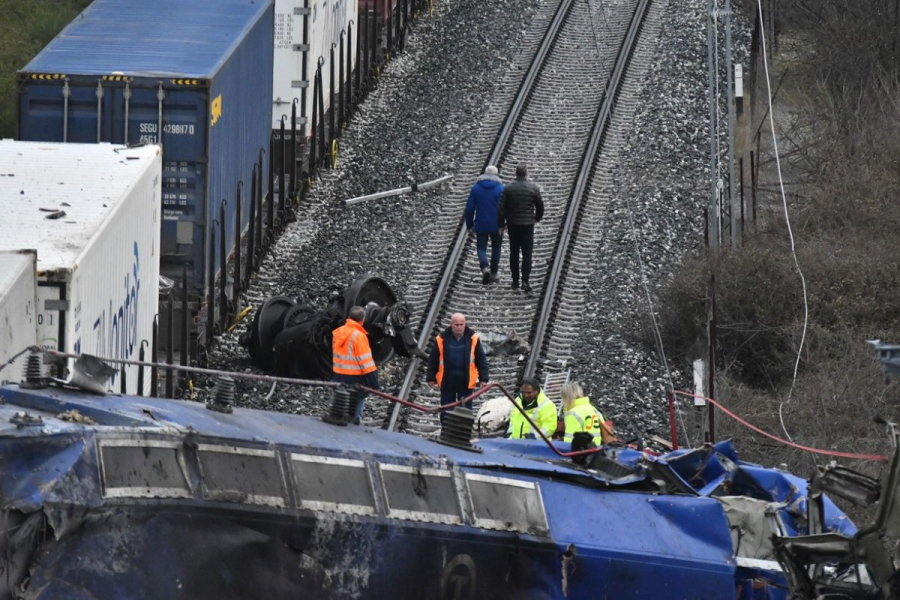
[0,140,162,393]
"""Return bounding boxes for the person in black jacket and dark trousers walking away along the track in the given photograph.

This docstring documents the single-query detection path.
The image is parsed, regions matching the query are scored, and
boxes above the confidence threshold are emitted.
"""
[497,162,544,293]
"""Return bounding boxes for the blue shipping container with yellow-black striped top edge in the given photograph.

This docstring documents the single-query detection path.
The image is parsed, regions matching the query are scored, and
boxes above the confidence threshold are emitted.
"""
[19,0,274,291]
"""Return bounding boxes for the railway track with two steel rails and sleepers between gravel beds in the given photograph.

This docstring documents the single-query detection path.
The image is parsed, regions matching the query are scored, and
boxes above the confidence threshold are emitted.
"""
[379,0,661,437]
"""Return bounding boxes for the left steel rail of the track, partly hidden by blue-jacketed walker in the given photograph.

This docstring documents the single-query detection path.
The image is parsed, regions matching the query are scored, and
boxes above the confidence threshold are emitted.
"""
[387,0,575,431]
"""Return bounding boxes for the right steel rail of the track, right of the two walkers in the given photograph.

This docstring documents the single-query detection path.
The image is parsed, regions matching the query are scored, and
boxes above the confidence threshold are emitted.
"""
[524,0,650,377]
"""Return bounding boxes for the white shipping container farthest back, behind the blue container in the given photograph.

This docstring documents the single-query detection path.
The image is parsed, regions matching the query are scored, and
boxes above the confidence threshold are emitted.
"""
[272,0,359,132]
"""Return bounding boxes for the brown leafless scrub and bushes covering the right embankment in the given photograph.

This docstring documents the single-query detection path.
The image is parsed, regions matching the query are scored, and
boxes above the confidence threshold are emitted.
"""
[648,0,900,516]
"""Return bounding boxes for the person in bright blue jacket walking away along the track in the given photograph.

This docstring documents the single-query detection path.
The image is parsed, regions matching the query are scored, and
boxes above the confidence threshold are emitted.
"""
[466,165,503,284]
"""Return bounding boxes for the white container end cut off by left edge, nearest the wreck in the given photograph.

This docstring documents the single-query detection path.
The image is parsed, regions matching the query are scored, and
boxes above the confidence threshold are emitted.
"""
[0,251,37,368]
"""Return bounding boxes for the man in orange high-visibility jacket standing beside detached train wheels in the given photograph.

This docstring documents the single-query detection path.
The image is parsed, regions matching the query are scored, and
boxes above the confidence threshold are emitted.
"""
[331,306,380,425]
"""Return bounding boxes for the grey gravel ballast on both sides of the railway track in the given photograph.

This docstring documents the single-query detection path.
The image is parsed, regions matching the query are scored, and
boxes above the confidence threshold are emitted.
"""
[200,0,747,442]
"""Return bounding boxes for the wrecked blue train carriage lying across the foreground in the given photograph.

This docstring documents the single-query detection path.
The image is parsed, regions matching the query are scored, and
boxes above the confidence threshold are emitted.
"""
[0,385,888,600]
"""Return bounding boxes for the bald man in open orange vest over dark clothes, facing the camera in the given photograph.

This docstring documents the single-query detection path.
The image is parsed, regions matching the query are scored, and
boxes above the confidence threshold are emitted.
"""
[425,313,490,425]
